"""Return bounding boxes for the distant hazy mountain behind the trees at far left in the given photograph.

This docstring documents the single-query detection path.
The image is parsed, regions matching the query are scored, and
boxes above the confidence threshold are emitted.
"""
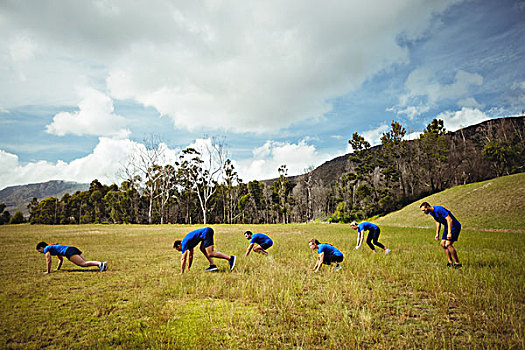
[0,180,89,216]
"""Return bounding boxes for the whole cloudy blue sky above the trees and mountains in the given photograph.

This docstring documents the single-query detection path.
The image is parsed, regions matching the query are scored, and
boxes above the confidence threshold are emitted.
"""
[0,0,525,189]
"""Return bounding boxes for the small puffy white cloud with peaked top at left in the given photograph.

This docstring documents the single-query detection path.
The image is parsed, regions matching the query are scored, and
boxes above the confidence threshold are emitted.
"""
[46,89,130,138]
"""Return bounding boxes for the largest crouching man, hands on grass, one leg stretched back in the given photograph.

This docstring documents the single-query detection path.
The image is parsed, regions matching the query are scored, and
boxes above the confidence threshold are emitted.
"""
[173,227,237,274]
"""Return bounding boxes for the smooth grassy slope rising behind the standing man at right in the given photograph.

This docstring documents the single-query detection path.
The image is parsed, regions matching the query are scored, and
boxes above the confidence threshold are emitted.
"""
[375,173,525,232]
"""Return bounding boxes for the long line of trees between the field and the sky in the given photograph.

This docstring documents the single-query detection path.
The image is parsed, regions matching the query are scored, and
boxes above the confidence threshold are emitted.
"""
[14,117,525,224]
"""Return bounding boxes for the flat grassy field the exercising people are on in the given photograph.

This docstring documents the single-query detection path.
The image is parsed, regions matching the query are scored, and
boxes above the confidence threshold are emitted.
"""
[0,224,525,349]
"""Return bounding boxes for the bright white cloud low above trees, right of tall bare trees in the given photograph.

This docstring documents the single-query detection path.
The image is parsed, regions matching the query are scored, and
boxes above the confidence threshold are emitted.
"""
[234,140,334,181]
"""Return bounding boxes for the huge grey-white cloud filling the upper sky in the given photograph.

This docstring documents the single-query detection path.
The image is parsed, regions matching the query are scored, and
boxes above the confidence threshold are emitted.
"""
[0,0,458,132]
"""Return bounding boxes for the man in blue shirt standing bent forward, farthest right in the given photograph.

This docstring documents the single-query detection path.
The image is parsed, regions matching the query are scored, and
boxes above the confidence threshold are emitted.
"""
[419,202,462,269]
